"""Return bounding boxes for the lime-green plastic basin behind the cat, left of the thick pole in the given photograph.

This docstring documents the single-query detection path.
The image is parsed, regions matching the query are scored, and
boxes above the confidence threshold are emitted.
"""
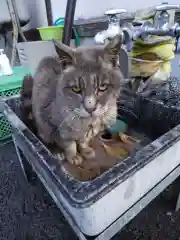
[38,25,64,40]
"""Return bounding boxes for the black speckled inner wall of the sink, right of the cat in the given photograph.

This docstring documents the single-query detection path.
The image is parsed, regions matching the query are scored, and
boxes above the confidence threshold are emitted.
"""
[119,77,180,136]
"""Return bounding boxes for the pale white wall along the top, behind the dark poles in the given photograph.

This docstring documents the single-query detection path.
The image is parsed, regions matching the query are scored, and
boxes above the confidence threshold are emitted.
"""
[28,0,180,27]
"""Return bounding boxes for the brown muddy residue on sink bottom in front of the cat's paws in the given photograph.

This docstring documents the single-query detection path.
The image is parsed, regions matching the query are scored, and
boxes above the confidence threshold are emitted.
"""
[62,131,150,181]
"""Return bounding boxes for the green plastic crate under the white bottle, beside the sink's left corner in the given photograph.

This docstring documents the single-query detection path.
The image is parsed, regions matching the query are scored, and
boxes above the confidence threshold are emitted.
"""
[0,66,31,142]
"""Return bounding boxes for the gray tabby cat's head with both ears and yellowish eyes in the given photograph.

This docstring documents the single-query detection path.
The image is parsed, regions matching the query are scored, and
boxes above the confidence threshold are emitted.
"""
[54,37,123,117]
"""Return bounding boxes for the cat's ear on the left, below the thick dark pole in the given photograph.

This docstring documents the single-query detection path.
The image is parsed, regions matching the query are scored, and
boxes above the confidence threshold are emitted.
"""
[52,40,75,66]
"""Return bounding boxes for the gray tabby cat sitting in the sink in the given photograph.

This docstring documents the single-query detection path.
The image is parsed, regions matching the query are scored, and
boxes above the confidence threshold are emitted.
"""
[32,37,122,165]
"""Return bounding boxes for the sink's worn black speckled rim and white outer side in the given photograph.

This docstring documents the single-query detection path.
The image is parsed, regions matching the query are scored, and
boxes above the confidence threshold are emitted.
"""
[0,96,180,236]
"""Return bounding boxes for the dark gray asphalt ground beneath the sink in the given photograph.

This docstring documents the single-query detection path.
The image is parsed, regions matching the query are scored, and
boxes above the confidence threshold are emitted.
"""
[0,144,180,240]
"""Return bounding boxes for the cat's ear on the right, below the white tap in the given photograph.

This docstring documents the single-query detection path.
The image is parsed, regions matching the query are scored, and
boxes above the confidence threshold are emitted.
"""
[104,36,122,67]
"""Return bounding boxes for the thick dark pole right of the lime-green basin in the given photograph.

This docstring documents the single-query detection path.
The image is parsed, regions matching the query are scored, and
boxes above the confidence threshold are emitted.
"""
[62,0,76,45]
